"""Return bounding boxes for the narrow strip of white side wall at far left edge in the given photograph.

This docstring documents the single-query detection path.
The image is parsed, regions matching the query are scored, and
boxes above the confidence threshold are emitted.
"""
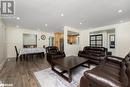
[0,19,6,69]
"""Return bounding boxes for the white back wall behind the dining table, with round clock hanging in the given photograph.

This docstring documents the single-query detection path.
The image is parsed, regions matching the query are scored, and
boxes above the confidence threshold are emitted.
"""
[6,27,53,58]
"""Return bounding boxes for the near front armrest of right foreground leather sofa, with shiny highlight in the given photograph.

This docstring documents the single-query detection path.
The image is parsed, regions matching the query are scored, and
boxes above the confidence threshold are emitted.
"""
[80,70,124,87]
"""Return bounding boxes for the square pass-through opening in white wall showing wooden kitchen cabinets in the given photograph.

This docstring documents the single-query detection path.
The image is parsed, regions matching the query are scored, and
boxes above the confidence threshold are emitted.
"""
[67,31,79,45]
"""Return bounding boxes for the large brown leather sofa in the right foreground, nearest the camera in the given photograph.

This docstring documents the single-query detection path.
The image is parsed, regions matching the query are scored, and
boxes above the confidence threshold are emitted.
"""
[80,53,130,87]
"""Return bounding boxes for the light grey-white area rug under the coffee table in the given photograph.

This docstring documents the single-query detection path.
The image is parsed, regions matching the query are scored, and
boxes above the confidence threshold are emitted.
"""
[34,65,95,87]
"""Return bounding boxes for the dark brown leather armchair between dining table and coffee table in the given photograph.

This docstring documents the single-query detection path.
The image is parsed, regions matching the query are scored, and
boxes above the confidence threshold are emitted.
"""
[46,46,66,64]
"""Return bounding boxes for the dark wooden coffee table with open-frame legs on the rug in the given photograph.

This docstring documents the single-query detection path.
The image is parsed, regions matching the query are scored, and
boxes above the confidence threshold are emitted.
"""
[51,56,90,82]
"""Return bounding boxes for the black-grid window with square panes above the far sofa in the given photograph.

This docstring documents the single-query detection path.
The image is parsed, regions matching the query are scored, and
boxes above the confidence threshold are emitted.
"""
[90,34,103,47]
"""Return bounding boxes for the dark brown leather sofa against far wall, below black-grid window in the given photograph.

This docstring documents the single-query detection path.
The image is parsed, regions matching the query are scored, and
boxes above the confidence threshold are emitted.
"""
[78,46,107,64]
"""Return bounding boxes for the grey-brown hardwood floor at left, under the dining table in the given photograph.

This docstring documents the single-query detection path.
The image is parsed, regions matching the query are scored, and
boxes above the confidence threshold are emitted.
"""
[0,58,50,87]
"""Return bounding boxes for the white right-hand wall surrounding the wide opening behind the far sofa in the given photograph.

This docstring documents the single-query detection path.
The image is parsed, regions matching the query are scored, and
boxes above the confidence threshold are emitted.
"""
[80,22,130,57]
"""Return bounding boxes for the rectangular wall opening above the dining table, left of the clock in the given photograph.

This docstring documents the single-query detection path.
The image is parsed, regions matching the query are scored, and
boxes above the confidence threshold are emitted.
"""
[23,34,37,48]
